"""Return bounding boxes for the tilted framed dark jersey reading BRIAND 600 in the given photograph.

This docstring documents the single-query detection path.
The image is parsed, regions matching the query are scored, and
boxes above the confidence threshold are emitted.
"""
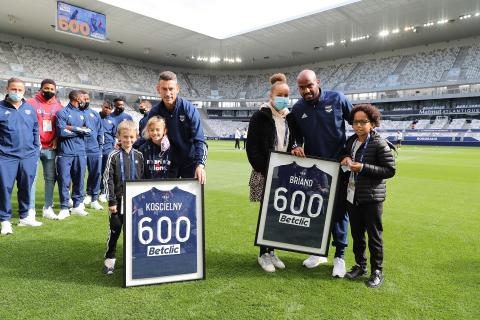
[255,152,340,256]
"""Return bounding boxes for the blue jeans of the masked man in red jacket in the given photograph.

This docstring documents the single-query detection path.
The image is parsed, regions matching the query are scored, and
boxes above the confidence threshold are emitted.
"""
[29,149,56,209]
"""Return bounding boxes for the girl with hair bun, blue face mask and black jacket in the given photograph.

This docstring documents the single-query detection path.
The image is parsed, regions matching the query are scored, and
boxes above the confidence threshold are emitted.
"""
[246,73,293,272]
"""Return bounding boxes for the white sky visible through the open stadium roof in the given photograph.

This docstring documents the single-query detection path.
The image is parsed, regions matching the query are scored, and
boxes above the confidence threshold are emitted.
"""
[100,0,361,40]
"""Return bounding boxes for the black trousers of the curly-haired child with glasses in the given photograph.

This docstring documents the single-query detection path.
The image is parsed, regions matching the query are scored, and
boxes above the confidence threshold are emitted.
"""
[347,202,383,271]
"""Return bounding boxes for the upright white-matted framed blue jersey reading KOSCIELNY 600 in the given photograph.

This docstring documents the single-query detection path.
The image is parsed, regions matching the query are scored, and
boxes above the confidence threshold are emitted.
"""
[123,179,205,287]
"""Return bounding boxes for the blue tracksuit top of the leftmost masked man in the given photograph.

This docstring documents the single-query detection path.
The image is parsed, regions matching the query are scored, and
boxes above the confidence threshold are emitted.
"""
[0,99,40,158]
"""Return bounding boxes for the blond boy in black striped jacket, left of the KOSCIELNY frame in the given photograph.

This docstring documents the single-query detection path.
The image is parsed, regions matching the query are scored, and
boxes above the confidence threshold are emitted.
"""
[103,120,143,274]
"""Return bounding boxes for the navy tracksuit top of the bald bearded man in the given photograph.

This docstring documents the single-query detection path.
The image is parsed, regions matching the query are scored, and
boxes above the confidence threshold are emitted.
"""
[292,90,352,160]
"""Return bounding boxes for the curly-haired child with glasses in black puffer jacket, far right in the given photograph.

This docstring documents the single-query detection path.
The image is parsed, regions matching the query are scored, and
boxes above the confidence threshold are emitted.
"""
[341,104,395,288]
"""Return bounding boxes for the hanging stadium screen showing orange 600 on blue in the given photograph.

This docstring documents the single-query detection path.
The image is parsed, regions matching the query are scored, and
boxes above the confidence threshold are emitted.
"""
[56,1,107,40]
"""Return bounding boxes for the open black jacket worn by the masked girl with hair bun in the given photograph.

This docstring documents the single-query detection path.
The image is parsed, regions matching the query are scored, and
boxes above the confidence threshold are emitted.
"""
[247,105,293,176]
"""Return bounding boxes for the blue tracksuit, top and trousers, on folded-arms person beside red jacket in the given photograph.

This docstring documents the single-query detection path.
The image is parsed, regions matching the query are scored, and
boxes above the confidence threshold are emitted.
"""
[56,103,91,209]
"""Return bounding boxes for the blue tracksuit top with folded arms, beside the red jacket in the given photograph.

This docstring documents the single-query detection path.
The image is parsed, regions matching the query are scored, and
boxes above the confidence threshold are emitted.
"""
[57,103,90,156]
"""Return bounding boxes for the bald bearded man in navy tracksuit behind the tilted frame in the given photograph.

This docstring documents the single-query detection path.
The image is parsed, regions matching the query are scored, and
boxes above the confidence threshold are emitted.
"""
[292,70,352,278]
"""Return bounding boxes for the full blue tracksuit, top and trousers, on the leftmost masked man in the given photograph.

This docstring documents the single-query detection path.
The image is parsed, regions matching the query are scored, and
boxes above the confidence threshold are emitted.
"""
[0,100,40,221]
